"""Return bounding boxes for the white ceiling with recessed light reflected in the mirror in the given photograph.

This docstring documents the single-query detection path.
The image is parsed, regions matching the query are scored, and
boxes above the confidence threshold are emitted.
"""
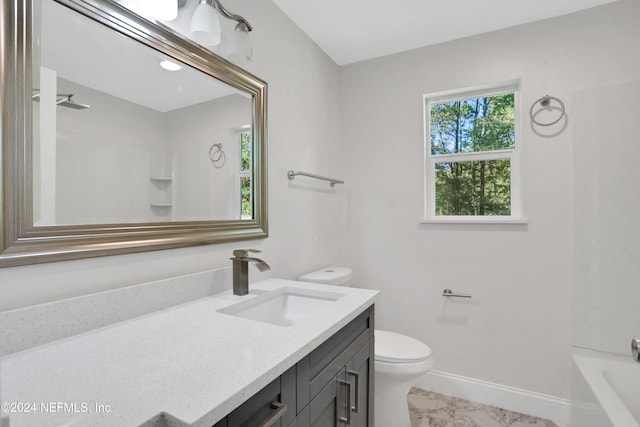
[40,1,239,112]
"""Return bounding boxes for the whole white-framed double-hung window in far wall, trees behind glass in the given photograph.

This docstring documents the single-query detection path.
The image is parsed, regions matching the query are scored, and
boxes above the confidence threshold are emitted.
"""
[424,85,522,222]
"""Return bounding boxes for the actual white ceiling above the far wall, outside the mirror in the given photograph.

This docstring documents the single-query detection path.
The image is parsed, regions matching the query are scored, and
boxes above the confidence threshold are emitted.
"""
[273,0,616,65]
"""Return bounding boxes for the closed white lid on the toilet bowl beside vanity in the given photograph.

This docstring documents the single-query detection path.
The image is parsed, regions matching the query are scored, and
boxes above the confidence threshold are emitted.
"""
[375,329,431,363]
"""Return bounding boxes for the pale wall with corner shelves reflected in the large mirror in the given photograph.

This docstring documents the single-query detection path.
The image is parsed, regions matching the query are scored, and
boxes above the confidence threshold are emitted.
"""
[52,85,253,225]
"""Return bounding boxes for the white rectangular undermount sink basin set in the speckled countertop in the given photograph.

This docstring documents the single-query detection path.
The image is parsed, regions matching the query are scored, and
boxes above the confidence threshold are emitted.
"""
[218,287,343,326]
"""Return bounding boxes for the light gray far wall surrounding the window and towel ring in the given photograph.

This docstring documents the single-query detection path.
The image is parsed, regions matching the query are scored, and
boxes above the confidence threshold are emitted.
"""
[336,1,640,398]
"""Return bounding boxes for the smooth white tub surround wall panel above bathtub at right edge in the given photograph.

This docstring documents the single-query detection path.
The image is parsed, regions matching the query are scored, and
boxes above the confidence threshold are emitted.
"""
[572,80,640,357]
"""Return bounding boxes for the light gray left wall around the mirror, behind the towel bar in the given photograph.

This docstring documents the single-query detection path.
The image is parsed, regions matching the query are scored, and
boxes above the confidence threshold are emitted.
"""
[0,0,340,310]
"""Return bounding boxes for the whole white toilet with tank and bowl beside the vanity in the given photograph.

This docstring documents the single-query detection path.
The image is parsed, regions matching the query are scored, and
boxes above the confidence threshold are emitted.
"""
[298,267,433,427]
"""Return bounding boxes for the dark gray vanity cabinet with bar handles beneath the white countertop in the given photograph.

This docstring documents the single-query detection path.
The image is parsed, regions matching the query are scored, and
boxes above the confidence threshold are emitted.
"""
[213,306,374,427]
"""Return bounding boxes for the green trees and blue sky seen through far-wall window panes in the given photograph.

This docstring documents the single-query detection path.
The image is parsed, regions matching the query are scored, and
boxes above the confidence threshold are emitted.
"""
[429,93,515,216]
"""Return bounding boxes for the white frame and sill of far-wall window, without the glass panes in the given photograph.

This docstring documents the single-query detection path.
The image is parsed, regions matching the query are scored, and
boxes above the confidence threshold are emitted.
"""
[421,81,527,224]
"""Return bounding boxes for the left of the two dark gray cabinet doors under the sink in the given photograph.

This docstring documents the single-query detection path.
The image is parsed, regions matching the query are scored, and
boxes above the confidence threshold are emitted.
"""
[308,369,352,427]
